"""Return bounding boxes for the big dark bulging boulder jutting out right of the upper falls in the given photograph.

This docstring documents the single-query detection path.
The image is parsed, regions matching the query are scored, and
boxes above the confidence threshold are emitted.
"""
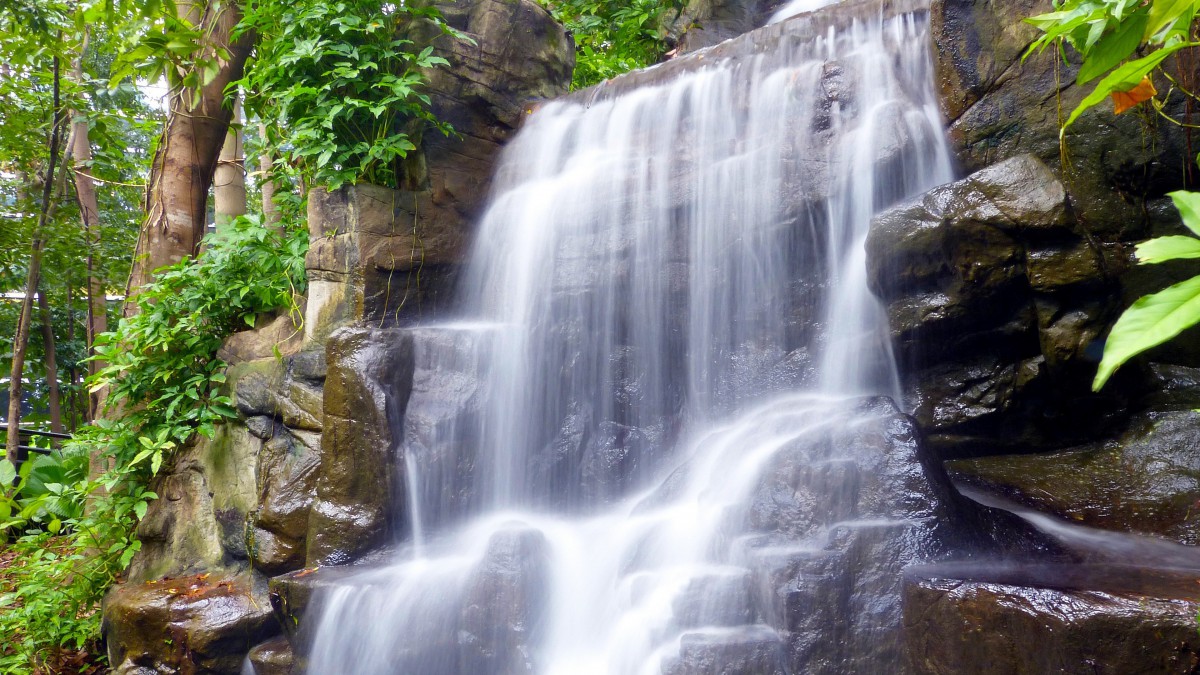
[866,155,1128,454]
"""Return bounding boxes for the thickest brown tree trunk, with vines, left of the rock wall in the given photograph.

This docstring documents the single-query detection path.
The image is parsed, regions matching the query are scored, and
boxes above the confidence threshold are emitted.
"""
[125,4,254,316]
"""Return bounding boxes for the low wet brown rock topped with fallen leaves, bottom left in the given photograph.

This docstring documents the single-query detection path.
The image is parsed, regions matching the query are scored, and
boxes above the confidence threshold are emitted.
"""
[103,573,278,675]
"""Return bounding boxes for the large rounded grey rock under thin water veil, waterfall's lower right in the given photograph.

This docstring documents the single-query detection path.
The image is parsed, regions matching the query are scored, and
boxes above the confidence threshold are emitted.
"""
[748,399,955,673]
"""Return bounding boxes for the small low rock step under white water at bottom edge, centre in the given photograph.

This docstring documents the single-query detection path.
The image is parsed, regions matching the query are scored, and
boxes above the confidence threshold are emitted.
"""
[662,625,791,675]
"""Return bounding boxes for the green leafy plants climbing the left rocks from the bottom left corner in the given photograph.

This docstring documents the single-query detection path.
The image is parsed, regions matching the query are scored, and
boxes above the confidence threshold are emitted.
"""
[0,216,308,673]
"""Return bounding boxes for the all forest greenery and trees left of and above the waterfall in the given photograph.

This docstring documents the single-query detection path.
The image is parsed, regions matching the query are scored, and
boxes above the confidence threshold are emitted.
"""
[0,0,682,673]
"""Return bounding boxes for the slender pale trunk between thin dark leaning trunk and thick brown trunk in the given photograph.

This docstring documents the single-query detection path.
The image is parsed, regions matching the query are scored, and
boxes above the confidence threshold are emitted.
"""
[71,31,108,422]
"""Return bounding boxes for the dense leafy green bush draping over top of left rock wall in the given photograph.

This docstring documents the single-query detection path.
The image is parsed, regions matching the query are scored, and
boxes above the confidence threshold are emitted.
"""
[240,0,452,189]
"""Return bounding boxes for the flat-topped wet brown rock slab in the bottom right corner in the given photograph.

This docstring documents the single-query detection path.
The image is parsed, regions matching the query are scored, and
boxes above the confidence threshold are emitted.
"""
[904,568,1200,675]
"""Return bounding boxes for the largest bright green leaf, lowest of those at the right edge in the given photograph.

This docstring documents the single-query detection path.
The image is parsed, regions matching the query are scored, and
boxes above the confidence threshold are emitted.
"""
[1092,276,1200,392]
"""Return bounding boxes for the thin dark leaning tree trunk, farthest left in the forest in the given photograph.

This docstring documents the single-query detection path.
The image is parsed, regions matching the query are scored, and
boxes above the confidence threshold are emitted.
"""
[7,51,66,464]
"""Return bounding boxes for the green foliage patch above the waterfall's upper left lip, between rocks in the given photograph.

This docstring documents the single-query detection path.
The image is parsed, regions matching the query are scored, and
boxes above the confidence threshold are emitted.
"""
[539,0,686,89]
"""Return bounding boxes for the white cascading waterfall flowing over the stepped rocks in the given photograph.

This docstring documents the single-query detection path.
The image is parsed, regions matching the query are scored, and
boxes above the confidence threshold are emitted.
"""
[305,2,950,675]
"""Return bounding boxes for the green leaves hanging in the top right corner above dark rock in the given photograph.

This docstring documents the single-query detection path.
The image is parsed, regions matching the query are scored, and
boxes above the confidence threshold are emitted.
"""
[1026,0,1200,133]
